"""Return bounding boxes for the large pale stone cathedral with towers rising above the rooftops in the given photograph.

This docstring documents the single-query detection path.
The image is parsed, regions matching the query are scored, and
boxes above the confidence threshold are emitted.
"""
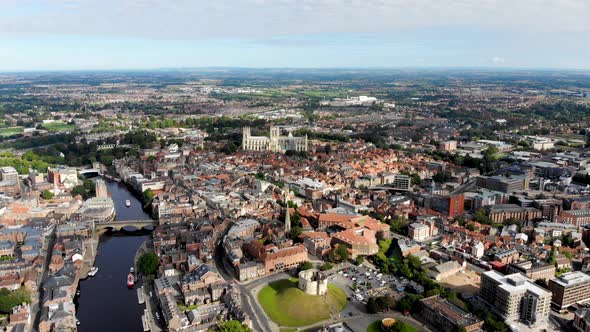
[242,126,307,153]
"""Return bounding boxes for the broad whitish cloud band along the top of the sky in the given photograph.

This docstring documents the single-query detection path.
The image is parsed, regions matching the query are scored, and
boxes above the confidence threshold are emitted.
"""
[0,0,590,39]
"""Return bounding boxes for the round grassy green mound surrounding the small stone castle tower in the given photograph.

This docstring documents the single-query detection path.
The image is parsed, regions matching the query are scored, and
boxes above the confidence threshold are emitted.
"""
[258,278,348,327]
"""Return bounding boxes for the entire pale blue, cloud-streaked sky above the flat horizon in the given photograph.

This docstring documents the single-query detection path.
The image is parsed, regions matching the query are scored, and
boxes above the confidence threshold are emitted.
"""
[0,0,590,71]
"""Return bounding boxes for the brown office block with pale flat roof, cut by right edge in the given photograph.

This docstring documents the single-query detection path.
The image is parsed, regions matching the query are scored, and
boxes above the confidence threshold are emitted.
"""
[549,271,590,310]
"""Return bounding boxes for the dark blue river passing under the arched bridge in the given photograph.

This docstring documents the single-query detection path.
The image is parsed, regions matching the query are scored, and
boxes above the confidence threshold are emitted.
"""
[77,181,150,332]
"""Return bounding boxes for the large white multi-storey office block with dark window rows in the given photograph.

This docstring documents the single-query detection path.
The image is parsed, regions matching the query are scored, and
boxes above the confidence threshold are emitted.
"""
[480,271,551,328]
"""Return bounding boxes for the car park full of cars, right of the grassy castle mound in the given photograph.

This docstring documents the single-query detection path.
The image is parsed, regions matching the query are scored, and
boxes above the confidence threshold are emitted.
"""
[330,265,410,304]
